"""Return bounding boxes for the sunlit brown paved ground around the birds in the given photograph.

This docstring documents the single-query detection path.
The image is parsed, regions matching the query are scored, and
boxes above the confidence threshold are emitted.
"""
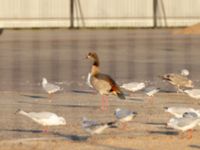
[0,29,200,150]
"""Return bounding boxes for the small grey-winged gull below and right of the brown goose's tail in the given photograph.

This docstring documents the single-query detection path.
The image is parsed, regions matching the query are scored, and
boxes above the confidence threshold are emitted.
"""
[114,108,137,122]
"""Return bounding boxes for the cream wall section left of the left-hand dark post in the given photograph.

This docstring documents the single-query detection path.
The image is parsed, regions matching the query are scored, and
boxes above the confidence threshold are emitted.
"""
[0,0,69,28]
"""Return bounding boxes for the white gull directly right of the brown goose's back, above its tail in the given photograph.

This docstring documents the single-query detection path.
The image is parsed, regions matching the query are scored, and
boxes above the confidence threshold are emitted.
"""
[121,82,145,92]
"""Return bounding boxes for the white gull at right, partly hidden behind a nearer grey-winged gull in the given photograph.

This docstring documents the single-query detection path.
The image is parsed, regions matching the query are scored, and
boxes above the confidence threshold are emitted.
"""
[164,107,200,118]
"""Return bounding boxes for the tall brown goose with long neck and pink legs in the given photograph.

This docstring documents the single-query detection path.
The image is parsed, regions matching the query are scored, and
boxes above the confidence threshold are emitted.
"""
[86,52,125,110]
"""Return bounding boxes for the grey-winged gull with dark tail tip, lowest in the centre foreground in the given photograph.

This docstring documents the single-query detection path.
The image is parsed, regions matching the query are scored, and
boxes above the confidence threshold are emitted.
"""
[82,117,115,135]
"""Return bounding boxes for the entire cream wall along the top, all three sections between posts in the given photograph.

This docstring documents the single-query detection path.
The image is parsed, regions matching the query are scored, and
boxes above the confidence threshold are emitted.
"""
[0,0,200,28]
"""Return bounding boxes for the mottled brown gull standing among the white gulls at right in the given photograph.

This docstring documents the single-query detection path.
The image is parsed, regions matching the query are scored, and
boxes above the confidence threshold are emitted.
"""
[160,73,194,92]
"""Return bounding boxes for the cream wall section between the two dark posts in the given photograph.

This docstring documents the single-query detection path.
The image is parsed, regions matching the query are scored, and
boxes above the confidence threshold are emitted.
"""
[75,0,153,27]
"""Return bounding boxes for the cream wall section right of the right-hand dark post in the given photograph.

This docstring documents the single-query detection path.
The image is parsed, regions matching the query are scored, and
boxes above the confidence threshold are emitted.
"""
[158,0,200,27]
